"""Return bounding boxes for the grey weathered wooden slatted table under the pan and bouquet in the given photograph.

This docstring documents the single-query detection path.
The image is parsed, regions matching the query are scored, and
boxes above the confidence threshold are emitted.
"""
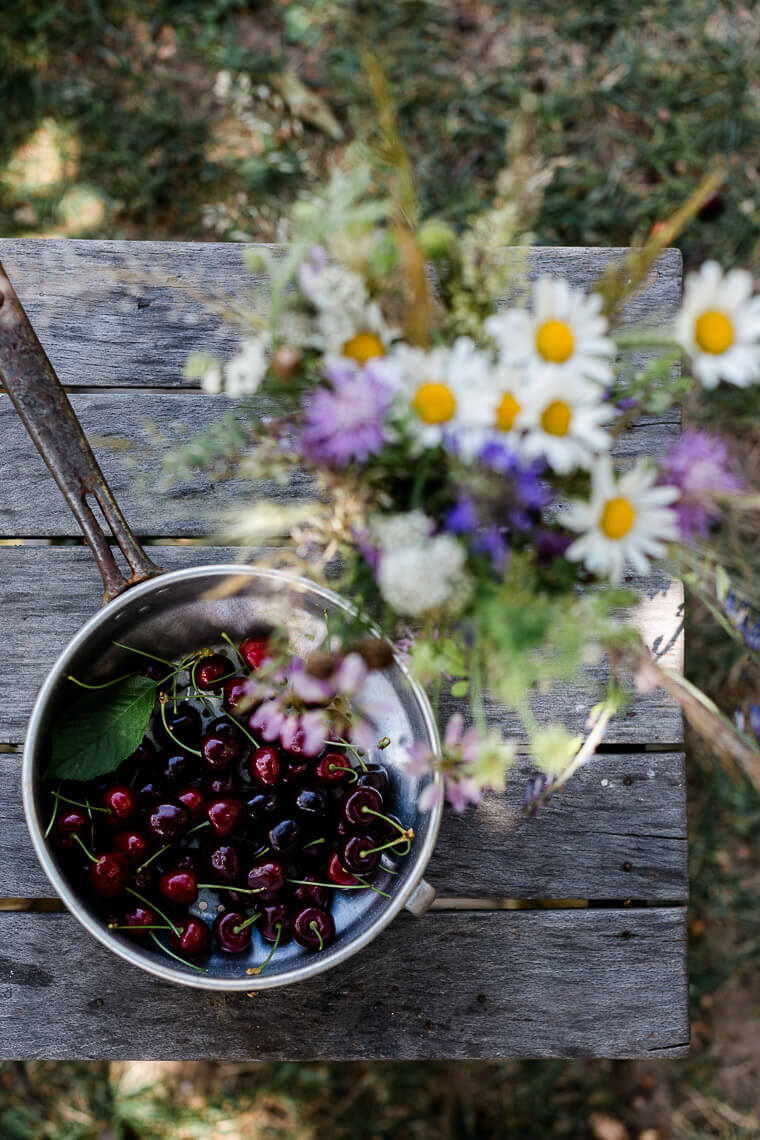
[0,239,689,1059]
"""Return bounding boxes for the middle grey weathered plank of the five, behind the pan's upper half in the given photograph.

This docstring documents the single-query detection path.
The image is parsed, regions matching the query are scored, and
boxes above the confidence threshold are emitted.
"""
[0,544,683,746]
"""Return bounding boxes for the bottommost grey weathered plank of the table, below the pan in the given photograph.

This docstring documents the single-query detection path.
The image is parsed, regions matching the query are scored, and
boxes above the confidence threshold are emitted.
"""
[0,907,689,1060]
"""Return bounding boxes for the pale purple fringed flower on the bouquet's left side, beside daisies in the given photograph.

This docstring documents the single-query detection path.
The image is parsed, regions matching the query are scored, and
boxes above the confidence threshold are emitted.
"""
[301,360,391,467]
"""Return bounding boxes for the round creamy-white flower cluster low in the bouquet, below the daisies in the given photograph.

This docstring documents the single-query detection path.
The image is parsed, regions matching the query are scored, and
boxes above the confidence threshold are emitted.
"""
[377,535,471,617]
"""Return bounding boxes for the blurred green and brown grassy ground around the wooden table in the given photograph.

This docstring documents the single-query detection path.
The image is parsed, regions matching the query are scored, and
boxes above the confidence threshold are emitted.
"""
[0,0,760,1140]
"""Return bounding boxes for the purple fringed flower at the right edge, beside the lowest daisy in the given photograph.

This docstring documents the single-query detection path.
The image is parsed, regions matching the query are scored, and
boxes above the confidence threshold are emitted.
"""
[661,429,744,539]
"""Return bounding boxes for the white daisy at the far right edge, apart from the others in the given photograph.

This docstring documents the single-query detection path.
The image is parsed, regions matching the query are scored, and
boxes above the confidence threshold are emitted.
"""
[675,261,760,388]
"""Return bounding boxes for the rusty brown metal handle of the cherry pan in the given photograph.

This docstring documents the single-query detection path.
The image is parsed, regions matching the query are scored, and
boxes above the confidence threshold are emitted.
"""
[0,262,161,603]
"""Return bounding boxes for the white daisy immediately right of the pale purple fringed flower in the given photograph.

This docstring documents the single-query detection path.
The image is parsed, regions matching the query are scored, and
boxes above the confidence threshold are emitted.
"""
[391,336,493,454]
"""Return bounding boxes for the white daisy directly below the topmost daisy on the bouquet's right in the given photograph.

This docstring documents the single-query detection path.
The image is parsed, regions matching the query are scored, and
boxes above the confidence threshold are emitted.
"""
[514,375,614,475]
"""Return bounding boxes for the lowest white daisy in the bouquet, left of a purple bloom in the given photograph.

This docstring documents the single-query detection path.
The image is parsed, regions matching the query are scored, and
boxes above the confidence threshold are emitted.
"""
[563,455,679,581]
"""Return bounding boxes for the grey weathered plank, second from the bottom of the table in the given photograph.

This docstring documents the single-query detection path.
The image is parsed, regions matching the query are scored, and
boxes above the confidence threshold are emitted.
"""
[0,752,688,902]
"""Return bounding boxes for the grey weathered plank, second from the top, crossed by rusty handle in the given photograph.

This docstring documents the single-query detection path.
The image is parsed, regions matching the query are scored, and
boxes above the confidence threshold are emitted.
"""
[0,392,679,537]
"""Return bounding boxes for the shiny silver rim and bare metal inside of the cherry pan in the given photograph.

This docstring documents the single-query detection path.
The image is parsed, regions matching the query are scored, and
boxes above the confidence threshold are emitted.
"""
[23,565,442,991]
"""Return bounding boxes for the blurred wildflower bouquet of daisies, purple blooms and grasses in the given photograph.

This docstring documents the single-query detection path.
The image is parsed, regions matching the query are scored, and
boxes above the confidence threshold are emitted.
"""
[175,91,760,808]
